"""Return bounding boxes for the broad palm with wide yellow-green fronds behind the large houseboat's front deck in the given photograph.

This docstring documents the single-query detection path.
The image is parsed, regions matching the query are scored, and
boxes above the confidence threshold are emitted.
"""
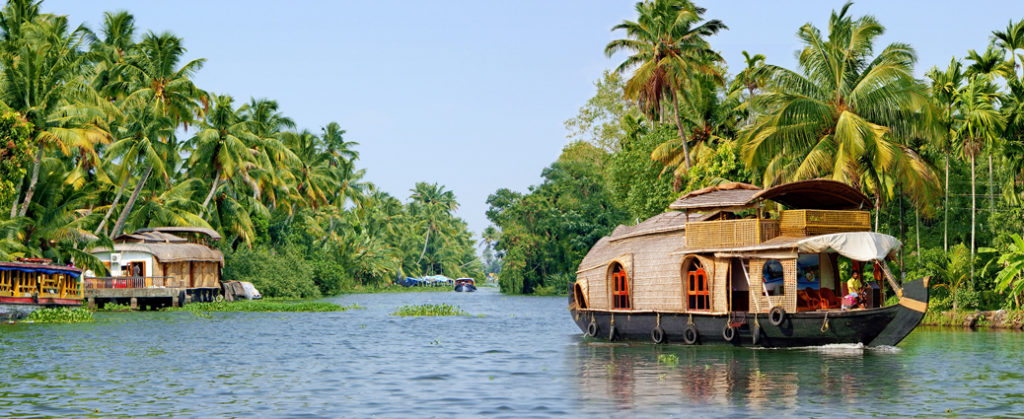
[739,3,939,220]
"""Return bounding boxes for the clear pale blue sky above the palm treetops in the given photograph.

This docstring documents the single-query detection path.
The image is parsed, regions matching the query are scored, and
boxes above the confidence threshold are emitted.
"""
[43,0,1024,233]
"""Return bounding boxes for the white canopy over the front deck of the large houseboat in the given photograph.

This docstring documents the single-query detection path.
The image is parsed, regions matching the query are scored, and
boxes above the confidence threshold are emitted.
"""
[797,232,903,262]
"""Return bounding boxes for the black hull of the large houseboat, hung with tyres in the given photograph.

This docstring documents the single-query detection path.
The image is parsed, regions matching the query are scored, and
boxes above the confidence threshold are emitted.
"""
[570,279,928,347]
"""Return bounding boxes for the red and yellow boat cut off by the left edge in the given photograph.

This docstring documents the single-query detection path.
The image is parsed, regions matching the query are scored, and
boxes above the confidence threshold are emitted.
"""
[0,258,82,320]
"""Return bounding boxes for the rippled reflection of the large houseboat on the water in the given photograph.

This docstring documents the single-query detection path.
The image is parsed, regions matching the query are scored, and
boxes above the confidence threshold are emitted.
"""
[569,340,907,415]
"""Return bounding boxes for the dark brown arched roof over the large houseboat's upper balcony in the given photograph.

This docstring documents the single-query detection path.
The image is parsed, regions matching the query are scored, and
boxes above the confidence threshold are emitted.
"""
[751,179,874,210]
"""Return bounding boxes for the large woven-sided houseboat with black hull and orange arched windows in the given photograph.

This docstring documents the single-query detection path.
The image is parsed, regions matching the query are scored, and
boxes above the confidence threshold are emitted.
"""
[569,180,929,347]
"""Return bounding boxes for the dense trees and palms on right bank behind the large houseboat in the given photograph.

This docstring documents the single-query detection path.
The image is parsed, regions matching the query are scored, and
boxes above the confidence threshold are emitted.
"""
[488,0,1024,309]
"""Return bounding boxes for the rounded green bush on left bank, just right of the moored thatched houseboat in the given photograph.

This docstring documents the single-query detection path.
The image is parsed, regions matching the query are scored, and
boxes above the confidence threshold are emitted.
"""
[222,248,322,298]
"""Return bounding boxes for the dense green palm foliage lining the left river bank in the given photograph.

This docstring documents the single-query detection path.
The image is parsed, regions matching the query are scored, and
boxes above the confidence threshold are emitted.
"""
[0,0,483,297]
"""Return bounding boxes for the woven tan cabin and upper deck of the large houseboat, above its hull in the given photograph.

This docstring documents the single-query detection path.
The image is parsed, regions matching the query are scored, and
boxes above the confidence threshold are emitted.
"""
[572,180,900,315]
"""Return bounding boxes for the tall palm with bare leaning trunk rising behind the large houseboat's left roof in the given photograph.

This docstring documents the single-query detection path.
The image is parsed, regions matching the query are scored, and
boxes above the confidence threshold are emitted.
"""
[604,0,727,170]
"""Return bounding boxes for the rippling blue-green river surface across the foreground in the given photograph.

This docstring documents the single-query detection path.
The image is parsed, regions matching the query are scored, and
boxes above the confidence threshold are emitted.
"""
[0,288,1024,418]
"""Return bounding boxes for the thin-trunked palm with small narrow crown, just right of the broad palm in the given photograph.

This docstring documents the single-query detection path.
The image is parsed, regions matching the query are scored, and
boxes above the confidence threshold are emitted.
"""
[926,57,964,251]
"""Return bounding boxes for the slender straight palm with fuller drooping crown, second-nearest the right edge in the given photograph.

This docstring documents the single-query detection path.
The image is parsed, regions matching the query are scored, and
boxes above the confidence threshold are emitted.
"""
[955,75,1006,281]
